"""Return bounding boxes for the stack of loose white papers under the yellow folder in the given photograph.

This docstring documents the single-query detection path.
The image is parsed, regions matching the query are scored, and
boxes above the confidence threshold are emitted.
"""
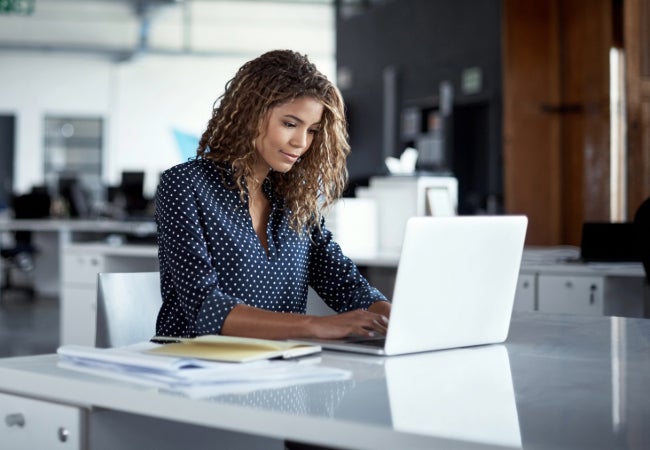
[57,343,350,397]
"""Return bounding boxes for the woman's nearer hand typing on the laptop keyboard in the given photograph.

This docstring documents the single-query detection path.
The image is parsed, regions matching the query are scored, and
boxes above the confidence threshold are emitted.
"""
[308,309,388,339]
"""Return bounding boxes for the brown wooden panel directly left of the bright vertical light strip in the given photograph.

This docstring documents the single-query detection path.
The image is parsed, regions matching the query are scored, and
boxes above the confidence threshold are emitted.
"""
[559,0,613,244]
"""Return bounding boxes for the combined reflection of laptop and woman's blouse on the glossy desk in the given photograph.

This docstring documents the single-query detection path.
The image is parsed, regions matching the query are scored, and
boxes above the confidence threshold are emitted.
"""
[212,345,521,448]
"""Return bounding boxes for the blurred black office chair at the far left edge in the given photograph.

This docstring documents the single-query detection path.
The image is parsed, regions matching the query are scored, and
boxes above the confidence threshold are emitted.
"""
[0,187,50,299]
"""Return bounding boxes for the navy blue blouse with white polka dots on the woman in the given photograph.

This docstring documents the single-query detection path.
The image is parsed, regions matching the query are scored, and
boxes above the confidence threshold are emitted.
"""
[155,159,386,337]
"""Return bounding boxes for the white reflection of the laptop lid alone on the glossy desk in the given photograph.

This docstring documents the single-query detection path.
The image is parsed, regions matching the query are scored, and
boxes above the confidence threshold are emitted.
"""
[386,345,521,448]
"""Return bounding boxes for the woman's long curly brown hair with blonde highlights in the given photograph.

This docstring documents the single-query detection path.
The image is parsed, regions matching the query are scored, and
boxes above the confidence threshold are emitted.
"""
[197,50,350,233]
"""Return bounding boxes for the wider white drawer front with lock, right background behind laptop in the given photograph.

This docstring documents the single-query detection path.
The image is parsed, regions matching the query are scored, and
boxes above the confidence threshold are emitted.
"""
[537,275,605,315]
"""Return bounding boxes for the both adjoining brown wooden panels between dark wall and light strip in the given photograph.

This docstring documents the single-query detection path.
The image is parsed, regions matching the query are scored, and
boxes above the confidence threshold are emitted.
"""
[503,0,613,245]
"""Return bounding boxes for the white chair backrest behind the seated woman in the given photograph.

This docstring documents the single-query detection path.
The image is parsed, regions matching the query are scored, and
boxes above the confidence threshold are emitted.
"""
[95,272,162,348]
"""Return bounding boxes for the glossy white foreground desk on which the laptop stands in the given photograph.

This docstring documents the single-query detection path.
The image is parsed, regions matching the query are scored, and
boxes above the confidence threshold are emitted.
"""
[0,313,650,450]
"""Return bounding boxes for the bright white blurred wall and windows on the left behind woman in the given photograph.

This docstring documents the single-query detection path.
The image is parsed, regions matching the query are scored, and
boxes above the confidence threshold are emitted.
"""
[0,0,335,220]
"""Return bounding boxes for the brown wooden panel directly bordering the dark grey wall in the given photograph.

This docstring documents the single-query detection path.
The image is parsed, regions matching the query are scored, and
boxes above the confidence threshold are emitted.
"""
[503,0,562,245]
